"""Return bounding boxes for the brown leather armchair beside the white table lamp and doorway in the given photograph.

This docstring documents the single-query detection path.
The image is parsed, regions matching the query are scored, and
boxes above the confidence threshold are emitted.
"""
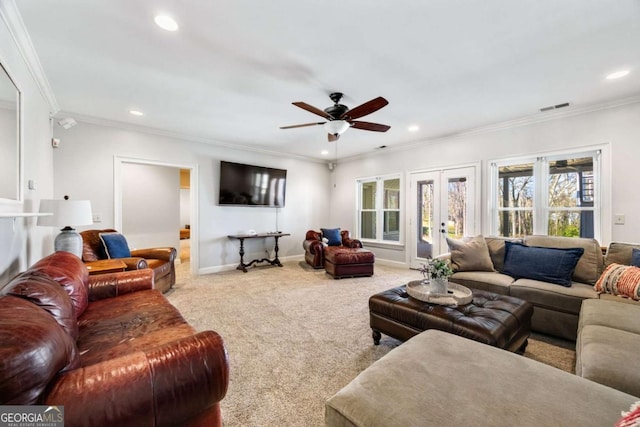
[80,229,178,292]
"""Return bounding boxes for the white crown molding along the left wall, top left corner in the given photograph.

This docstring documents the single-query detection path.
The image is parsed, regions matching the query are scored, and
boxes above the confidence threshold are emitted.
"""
[0,0,60,114]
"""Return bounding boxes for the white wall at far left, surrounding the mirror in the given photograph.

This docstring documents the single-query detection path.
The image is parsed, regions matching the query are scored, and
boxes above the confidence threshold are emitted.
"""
[0,2,53,281]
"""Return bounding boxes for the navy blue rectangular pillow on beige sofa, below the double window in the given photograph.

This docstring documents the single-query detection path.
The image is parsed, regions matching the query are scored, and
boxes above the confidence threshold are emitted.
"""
[502,241,584,287]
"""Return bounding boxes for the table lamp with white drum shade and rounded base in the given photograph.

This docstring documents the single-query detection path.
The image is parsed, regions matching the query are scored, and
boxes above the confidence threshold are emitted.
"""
[38,196,93,258]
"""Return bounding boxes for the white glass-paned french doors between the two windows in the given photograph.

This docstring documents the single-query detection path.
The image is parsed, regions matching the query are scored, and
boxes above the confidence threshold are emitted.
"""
[409,166,479,268]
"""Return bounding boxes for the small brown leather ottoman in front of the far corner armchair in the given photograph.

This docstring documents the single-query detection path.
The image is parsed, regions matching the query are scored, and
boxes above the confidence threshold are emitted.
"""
[324,246,375,279]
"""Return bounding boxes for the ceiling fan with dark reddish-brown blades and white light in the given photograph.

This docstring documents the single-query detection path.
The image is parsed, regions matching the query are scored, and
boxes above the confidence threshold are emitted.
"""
[280,92,391,142]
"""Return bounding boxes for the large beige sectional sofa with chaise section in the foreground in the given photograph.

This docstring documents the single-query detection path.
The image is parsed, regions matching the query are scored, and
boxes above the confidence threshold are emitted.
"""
[325,236,640,427]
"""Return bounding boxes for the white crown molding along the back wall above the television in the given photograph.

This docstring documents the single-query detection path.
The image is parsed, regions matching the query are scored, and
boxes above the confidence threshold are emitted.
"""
[56,111,326,164]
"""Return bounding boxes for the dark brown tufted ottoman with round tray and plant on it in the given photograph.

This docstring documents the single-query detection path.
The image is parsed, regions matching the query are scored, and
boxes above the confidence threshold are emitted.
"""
[369,286,533,353]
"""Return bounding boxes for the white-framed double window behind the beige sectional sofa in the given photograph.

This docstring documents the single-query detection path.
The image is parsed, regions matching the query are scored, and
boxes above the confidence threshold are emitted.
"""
[491,151,600,238]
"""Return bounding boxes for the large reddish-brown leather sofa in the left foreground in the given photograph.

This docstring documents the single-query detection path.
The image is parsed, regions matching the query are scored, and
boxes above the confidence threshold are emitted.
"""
[0,252,229,426]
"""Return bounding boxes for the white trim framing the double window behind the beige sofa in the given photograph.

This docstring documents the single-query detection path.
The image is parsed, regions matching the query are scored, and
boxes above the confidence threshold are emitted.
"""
[487,143,611,244]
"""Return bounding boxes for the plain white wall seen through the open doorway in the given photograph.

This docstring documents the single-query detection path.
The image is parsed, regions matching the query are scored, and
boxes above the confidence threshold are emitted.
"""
[121,163,180,250]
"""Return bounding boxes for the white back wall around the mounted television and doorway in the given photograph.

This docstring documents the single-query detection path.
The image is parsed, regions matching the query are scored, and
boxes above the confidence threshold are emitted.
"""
[54,118,330,273]
